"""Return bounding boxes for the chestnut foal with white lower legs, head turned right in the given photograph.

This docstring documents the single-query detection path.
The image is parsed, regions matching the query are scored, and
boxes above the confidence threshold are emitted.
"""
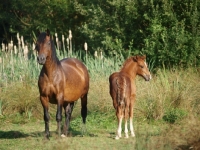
[109,56,151,139]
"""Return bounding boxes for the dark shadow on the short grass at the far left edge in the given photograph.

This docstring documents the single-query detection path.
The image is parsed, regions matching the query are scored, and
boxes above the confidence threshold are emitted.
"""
[0,131,29,139]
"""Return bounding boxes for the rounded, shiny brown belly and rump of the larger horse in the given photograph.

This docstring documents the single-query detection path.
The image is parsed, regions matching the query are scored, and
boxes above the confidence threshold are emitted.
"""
[61,58,89,101]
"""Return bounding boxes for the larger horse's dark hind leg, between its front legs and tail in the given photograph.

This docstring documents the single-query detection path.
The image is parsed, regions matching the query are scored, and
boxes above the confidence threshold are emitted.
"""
[62,102,74,137]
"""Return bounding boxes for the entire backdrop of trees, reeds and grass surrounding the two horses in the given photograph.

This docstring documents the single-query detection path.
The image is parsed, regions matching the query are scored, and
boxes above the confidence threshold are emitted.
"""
[0,0,200,150]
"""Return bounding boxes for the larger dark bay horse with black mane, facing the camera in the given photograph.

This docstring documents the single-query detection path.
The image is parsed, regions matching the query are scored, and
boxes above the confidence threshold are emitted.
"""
[35,29,89,139]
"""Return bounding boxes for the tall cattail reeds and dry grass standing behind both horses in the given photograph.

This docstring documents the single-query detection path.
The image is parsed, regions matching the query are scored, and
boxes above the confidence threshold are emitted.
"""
[0,32,200,123]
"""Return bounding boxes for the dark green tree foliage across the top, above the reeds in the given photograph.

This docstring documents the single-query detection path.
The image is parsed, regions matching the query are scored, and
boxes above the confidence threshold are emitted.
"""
[0,0,200,68]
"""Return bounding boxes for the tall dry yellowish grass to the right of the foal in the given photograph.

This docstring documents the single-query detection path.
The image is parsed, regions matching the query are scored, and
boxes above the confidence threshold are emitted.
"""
[137,68,200,123]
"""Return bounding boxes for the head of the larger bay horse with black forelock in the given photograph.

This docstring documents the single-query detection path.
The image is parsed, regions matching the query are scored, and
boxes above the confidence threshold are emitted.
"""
[35,29,52,65]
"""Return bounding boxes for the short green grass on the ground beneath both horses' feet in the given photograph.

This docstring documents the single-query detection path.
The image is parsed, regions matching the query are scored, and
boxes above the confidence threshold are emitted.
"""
[0,110,200,150]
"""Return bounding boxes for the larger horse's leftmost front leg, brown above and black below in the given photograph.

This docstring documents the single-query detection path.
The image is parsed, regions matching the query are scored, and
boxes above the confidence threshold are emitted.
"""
[40,96,50,139]
